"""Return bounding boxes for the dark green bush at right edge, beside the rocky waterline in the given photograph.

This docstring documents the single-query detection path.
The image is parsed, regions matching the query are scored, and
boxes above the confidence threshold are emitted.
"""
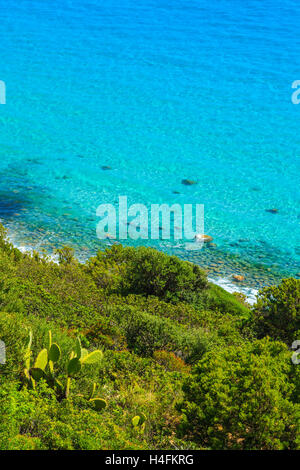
[253,279,300,346]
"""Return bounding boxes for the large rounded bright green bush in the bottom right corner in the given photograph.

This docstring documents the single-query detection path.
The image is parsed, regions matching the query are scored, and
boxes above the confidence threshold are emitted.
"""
[180,340,300,450]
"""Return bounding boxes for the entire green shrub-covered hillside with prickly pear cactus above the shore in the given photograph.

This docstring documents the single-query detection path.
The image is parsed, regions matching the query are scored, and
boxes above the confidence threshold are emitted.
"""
[0,228,300,450]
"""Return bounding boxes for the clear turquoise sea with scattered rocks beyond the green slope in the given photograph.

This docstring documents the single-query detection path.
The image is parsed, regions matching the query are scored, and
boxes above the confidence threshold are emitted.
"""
[0,0,300,294]
